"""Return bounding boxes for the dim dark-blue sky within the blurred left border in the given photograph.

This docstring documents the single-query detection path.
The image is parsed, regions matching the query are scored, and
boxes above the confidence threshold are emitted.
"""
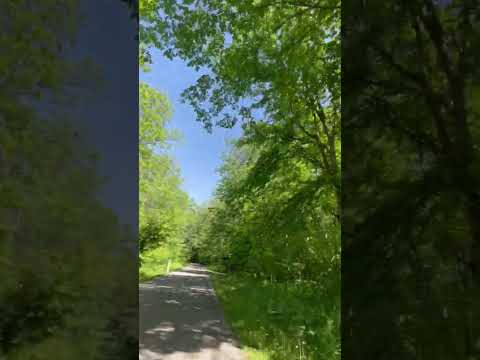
[61,0,138,229]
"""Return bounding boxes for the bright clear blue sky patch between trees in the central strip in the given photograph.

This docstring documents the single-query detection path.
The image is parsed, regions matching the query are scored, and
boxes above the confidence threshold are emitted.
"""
[140,51,241,204]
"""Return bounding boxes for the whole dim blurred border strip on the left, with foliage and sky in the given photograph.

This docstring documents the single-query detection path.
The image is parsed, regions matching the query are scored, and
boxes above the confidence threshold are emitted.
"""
[0,0,138,360]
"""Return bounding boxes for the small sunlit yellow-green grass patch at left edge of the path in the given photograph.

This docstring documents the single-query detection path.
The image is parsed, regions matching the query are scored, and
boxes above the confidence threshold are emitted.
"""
[139,246,185,282]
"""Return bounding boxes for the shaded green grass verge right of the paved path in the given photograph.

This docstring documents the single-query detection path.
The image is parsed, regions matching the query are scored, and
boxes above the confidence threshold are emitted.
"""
[214,274,340,360]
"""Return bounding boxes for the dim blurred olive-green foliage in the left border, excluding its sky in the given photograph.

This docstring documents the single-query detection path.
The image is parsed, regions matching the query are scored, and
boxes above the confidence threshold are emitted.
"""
[0,0,138,360]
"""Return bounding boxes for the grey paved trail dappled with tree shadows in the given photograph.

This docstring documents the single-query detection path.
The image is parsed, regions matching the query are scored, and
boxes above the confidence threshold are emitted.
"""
[139,264,246,360]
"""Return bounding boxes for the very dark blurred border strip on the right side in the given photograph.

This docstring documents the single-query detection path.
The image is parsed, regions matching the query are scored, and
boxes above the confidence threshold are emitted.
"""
[342,0,480,360]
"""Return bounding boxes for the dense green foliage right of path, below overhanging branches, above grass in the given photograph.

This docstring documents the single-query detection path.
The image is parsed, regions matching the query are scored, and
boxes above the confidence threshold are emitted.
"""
[190,144,340,286]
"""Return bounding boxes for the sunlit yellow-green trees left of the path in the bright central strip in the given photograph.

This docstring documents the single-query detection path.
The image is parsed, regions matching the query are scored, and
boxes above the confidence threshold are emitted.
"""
[139,82,191,272]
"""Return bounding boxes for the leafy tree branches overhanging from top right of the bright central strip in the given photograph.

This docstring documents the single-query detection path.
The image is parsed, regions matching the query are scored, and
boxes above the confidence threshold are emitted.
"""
[141,0,340,211]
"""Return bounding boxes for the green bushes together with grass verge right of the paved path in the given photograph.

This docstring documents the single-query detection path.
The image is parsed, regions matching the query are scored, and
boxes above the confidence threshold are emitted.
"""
[188,136,340,360]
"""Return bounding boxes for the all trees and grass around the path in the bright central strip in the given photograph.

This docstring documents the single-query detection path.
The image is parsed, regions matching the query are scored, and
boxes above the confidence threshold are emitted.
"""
[139,0,341,359]
